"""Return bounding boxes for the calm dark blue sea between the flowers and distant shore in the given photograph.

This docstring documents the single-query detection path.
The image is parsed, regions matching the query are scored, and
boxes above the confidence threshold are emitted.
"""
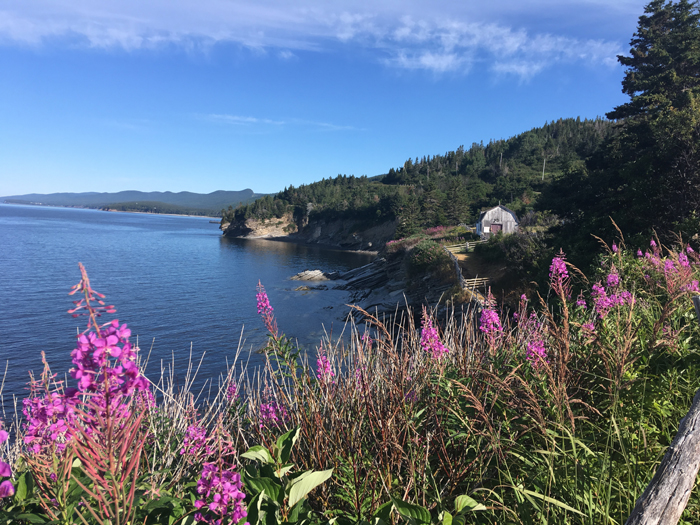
[0,204,372,415]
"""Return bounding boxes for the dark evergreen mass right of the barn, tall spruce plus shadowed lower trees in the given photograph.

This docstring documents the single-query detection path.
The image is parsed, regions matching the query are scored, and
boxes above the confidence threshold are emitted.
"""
[540,0,700,266]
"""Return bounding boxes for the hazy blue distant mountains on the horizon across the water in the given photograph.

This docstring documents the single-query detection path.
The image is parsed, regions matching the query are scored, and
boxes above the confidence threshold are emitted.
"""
[0,189,262,215]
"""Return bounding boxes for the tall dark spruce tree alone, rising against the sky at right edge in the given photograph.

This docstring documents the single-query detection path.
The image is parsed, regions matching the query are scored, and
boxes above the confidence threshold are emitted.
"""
[603,0,700,233]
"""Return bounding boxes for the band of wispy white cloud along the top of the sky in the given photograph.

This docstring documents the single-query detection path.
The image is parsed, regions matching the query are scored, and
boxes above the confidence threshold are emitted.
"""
[0,0,628,79]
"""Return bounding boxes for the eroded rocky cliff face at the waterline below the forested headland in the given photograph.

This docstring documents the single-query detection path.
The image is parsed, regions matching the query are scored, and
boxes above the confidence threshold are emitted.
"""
[222,214,396,251]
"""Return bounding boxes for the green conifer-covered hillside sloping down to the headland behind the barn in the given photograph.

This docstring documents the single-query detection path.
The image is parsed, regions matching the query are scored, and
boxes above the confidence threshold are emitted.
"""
[222,118,613,236]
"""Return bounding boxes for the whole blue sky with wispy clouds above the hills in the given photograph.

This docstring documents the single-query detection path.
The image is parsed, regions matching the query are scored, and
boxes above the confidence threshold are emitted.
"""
[0,0,645,195]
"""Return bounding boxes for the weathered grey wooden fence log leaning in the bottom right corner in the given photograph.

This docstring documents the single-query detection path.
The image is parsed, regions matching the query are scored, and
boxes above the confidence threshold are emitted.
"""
[625,296,700,525]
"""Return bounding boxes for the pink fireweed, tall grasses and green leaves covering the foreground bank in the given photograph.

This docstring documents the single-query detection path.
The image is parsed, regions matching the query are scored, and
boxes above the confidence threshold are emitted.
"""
[0,231,700,524]
